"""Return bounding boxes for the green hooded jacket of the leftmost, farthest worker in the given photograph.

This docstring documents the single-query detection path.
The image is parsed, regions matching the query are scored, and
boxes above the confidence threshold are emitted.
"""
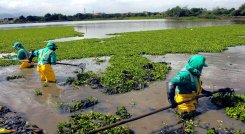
[13,42,30,60]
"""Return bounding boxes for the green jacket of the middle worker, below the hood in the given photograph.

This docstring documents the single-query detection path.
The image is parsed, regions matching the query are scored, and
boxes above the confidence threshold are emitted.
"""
[33,47,56,65]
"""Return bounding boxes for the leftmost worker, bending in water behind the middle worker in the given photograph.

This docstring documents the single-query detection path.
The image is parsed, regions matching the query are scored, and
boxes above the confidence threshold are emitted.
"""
[13,42,34,69]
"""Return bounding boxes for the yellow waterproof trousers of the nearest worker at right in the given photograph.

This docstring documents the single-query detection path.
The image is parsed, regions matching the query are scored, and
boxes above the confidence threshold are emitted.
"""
[175,93,198,112]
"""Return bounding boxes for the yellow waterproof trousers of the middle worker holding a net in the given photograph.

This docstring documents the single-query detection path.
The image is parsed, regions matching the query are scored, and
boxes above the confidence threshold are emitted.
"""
[37,64,56,82]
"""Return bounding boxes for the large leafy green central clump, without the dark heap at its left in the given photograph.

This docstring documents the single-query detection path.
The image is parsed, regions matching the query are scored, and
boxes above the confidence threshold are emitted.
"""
[102,55,169,94]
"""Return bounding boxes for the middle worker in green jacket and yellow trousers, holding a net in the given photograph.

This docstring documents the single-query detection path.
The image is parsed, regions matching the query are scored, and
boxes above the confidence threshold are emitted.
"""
[29,41,58,82]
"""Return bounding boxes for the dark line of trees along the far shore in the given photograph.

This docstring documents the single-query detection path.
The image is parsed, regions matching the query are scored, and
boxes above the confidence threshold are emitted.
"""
[14,3,245,23]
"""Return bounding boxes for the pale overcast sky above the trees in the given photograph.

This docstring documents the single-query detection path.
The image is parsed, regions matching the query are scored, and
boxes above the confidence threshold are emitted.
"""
[0,0,245,16]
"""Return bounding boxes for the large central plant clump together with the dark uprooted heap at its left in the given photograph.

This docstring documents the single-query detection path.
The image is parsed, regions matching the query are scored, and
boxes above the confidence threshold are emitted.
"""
[66,55,170,94]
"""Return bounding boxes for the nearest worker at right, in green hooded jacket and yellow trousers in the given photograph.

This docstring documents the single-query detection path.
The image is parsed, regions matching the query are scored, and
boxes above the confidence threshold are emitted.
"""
[168,55,212,112]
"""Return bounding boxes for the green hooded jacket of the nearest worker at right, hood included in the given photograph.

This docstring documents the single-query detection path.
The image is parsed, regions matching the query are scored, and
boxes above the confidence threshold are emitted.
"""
[171,55,207,94]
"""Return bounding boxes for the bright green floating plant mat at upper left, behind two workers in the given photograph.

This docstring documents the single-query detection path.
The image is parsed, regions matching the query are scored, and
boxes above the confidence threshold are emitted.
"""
[0,26,81,53]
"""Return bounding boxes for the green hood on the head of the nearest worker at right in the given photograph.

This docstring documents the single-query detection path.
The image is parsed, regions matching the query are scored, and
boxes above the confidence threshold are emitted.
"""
[185,55,208,76]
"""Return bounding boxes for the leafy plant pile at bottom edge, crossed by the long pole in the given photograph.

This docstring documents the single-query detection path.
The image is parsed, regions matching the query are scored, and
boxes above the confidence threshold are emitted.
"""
[58,112,133,134]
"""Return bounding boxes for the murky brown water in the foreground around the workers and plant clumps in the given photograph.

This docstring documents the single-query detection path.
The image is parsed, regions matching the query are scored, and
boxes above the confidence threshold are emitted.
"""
[0,46,245,134]
